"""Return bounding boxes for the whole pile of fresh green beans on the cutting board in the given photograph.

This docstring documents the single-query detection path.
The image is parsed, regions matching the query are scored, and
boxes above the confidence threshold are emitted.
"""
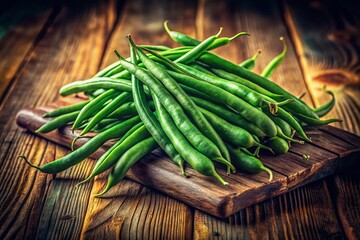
[21,22,339,197]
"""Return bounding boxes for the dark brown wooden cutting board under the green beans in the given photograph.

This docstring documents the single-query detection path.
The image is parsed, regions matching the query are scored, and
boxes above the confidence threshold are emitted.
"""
[17,100,360,217]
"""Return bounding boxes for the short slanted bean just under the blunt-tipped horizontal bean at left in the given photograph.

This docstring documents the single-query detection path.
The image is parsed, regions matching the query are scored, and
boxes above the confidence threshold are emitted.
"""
[71,89,117,130]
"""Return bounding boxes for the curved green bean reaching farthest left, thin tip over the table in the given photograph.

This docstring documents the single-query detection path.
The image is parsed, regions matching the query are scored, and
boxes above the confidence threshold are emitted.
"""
[21,116,140,174]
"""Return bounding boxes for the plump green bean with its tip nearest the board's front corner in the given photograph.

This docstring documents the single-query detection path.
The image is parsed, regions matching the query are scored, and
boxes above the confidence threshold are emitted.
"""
[152,94,228,185]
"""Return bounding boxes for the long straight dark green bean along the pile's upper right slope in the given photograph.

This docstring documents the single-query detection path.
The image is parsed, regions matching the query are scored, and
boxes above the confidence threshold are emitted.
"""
[198,52,318,121]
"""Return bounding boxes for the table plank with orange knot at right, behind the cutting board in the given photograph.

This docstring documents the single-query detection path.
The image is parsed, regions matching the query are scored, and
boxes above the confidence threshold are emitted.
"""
[284,1,360,134]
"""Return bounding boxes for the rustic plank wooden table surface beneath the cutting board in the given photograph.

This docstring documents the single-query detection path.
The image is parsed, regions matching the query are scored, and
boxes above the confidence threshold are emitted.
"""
[0,0,360,239]
